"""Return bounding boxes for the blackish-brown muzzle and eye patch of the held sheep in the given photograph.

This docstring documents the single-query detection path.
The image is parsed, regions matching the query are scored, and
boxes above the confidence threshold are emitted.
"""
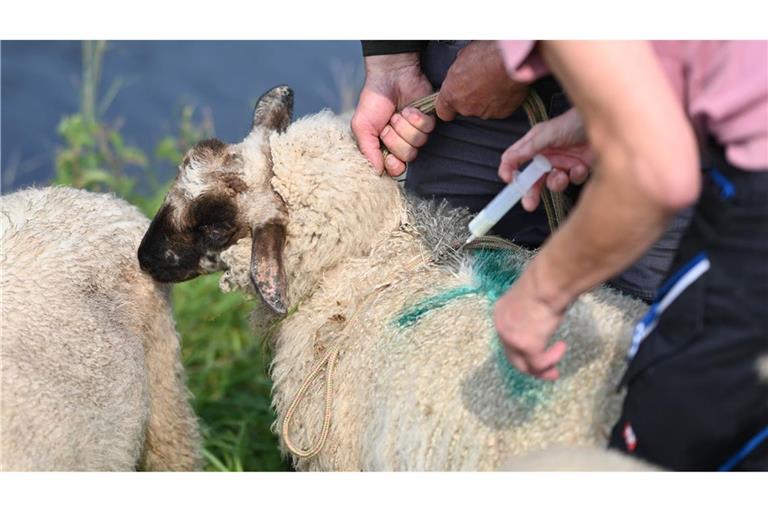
[138,195,247,283]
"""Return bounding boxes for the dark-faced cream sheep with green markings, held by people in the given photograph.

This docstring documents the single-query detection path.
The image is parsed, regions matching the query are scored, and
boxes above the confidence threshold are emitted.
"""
[138,86,646,470]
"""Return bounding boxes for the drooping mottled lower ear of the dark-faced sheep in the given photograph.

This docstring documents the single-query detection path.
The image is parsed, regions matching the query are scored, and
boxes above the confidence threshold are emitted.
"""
[250,224,288,315]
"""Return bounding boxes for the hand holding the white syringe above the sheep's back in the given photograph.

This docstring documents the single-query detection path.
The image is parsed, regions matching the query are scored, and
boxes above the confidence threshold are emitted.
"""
[498,108,592,212]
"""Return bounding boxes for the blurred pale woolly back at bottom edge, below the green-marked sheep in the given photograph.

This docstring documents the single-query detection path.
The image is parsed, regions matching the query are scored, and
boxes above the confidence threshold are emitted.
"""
[504,445,662,471]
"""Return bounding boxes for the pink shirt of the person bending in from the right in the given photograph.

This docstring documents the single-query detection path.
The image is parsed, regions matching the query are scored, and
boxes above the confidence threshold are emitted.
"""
[499,41,768,170]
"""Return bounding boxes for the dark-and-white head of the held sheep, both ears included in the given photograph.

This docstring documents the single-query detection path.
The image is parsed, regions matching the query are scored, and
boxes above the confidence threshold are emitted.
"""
[138,86,293,314]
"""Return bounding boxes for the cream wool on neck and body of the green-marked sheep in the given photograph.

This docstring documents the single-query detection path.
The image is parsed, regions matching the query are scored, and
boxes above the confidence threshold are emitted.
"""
[216,113,646,470]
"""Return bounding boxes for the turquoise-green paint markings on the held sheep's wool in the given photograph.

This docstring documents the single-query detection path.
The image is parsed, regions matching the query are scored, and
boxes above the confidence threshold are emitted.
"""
[395,249,552,408]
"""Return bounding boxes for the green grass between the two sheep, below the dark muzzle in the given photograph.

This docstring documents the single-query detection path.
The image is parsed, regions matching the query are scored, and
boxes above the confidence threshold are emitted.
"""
[173,275,289,471]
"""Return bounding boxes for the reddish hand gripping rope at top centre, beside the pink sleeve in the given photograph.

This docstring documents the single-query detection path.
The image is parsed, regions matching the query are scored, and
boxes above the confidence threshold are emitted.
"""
[435,41,528,121]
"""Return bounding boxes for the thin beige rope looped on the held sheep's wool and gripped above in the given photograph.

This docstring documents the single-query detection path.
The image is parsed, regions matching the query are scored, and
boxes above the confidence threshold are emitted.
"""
[281,89,567,458]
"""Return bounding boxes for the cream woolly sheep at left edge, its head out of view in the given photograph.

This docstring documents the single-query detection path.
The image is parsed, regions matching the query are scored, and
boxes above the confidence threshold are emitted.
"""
[0,187,201,471]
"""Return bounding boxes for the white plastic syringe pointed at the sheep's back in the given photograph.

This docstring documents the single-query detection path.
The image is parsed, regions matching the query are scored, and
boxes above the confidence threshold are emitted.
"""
[464,155,552,245]
